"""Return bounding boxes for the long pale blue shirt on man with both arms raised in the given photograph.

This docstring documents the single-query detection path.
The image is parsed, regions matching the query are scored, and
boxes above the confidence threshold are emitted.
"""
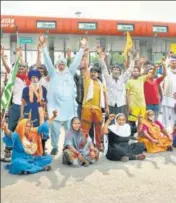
[43,47,84,121]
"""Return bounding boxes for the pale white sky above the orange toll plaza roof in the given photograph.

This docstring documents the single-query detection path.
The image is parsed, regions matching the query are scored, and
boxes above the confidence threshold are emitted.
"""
[1,1,176,22]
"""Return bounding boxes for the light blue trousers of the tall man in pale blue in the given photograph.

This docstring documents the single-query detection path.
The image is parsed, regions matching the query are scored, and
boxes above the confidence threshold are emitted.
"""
[51,120,71,149]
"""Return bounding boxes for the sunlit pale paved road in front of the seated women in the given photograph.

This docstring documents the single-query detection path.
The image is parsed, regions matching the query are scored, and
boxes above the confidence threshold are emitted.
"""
[1,128,176,203]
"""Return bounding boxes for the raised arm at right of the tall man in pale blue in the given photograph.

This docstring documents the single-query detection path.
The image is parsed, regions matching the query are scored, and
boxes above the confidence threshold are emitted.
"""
[69,38,87,76]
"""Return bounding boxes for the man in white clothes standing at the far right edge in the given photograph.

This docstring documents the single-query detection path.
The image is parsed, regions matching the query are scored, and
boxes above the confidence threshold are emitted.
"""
[162,55,176,132]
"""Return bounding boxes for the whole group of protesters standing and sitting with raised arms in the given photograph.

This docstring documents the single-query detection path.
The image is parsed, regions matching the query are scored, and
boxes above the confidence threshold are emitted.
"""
[1,35,176,174]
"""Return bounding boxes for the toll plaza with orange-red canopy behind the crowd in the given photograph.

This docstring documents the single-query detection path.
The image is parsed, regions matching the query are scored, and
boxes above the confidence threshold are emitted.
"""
[1,15,176,65]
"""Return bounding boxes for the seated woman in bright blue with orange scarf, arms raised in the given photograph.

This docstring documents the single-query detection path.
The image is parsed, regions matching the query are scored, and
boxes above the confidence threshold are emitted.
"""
[1,111,57,175]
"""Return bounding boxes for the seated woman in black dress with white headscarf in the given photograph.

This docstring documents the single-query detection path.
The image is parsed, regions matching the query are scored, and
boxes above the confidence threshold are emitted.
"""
[103,113,145,162]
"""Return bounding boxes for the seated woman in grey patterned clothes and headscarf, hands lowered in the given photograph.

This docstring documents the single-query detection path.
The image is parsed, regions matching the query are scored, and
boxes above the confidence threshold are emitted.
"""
[63,117,99,167]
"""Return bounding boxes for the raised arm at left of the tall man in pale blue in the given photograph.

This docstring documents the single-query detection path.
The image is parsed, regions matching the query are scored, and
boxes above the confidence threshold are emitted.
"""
[39,35,55,77]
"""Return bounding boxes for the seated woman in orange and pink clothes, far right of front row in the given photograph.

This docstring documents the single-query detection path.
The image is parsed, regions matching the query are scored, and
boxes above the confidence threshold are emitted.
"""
[138,110,173,153]
